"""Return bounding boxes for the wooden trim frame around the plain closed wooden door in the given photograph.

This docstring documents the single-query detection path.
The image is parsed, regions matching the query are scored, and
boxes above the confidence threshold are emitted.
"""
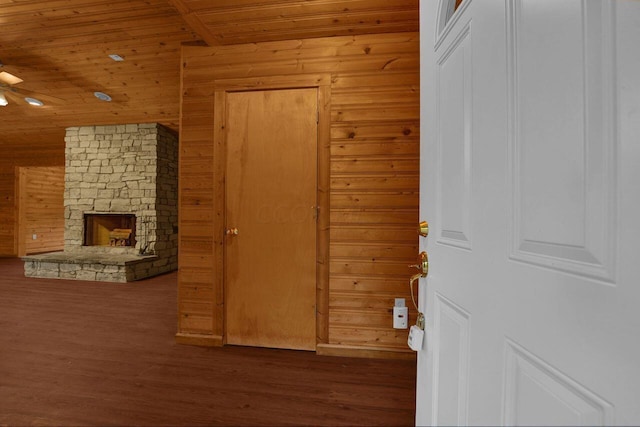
[213,74,331,345]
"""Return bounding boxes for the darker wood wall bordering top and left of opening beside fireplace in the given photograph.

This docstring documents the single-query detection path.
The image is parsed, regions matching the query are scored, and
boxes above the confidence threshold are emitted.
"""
[0,140,64,256]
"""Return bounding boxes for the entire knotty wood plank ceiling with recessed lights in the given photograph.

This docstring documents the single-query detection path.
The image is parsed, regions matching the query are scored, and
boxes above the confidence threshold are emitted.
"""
[0,0,419,144]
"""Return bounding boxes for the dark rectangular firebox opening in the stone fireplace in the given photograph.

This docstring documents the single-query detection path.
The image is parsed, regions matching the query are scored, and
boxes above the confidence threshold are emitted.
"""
[84,214,136,247]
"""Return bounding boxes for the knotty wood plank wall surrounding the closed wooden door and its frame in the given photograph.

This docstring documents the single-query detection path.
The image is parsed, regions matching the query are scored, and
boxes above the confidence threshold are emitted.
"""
[177,33,419,357]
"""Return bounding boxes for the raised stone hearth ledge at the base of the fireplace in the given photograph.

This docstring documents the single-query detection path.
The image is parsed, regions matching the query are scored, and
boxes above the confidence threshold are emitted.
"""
[22,251,169,282]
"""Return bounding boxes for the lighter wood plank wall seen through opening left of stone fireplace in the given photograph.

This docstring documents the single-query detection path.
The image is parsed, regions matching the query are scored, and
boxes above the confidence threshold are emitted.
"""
[17,166,64,256]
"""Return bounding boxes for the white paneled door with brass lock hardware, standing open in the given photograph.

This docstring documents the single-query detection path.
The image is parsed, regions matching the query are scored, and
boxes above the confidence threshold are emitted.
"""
[416,0,640,425]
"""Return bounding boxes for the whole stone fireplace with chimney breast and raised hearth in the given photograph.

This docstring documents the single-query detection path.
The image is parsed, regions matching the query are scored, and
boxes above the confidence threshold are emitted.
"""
[24,123,178,282]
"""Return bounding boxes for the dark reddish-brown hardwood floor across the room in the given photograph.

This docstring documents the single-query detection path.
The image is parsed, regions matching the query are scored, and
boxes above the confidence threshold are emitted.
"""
[0,258,415,426]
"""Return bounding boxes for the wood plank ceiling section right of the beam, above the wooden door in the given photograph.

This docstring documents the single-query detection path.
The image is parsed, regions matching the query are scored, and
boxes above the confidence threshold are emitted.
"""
[172,0,419,45]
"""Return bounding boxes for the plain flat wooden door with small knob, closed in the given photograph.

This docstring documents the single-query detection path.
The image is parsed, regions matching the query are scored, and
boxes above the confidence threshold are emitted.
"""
[225,89,318,350]
